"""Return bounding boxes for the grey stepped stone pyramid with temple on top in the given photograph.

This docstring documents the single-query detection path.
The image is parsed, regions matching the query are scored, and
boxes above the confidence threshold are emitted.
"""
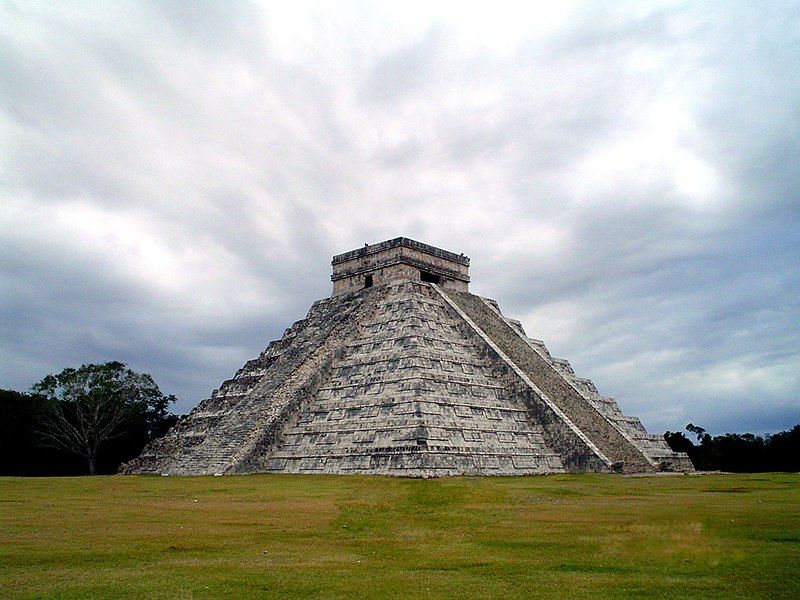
[122,237,692,477]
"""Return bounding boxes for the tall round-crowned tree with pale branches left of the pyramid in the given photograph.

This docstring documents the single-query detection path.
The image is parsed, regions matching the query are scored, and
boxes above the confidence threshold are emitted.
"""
[32,361,175,475]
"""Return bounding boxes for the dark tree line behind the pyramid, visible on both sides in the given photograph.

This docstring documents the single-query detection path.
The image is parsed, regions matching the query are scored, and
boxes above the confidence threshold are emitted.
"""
[0,361,800,476]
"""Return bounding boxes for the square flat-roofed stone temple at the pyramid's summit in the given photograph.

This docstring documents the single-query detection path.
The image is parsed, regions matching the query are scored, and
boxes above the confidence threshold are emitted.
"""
[331,237,469,296]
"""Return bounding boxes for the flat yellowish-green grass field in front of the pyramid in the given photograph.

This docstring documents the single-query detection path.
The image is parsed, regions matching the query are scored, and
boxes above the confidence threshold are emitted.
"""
[0,474,800,598]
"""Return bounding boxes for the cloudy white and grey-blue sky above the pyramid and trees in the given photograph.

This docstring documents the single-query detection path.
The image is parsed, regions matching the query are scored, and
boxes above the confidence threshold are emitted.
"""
[0,0,800,433]
